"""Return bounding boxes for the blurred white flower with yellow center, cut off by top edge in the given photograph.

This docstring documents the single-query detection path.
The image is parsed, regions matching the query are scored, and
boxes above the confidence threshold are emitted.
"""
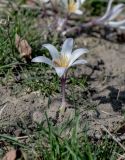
[62,0,85,15]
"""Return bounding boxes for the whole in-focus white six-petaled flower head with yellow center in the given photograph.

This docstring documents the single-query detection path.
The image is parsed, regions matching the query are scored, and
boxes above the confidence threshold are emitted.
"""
[32,38,88,77]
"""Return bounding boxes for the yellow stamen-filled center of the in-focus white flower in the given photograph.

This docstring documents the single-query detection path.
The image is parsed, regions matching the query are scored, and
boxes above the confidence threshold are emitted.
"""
[53,55,69,67]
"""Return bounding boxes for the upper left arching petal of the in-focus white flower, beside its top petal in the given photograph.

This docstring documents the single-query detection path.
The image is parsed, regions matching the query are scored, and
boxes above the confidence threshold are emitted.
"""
[43,44,59,59]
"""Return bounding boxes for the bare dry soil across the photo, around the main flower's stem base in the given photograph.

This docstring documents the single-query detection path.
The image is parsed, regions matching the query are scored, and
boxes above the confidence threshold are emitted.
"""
[0,35,125,138]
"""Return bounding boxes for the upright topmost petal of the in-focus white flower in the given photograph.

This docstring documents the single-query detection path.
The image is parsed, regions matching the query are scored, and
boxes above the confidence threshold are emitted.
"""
[61,38,73,57]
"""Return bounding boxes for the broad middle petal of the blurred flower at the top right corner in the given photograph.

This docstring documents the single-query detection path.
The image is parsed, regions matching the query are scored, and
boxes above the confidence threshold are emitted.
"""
[108,4,125,20]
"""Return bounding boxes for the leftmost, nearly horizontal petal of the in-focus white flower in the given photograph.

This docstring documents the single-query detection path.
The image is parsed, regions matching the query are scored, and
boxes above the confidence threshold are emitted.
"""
[31,56,52,66]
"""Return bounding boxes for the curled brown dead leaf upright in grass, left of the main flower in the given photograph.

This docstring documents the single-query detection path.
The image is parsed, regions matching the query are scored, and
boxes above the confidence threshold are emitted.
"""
[15,34,32,59]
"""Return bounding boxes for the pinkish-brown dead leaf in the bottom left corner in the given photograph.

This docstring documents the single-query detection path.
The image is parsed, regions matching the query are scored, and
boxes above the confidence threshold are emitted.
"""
[2,149,16,160]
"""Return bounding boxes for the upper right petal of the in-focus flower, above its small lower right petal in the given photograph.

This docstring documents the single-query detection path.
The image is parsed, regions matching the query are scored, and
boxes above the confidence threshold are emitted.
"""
[69,48,88,66]
